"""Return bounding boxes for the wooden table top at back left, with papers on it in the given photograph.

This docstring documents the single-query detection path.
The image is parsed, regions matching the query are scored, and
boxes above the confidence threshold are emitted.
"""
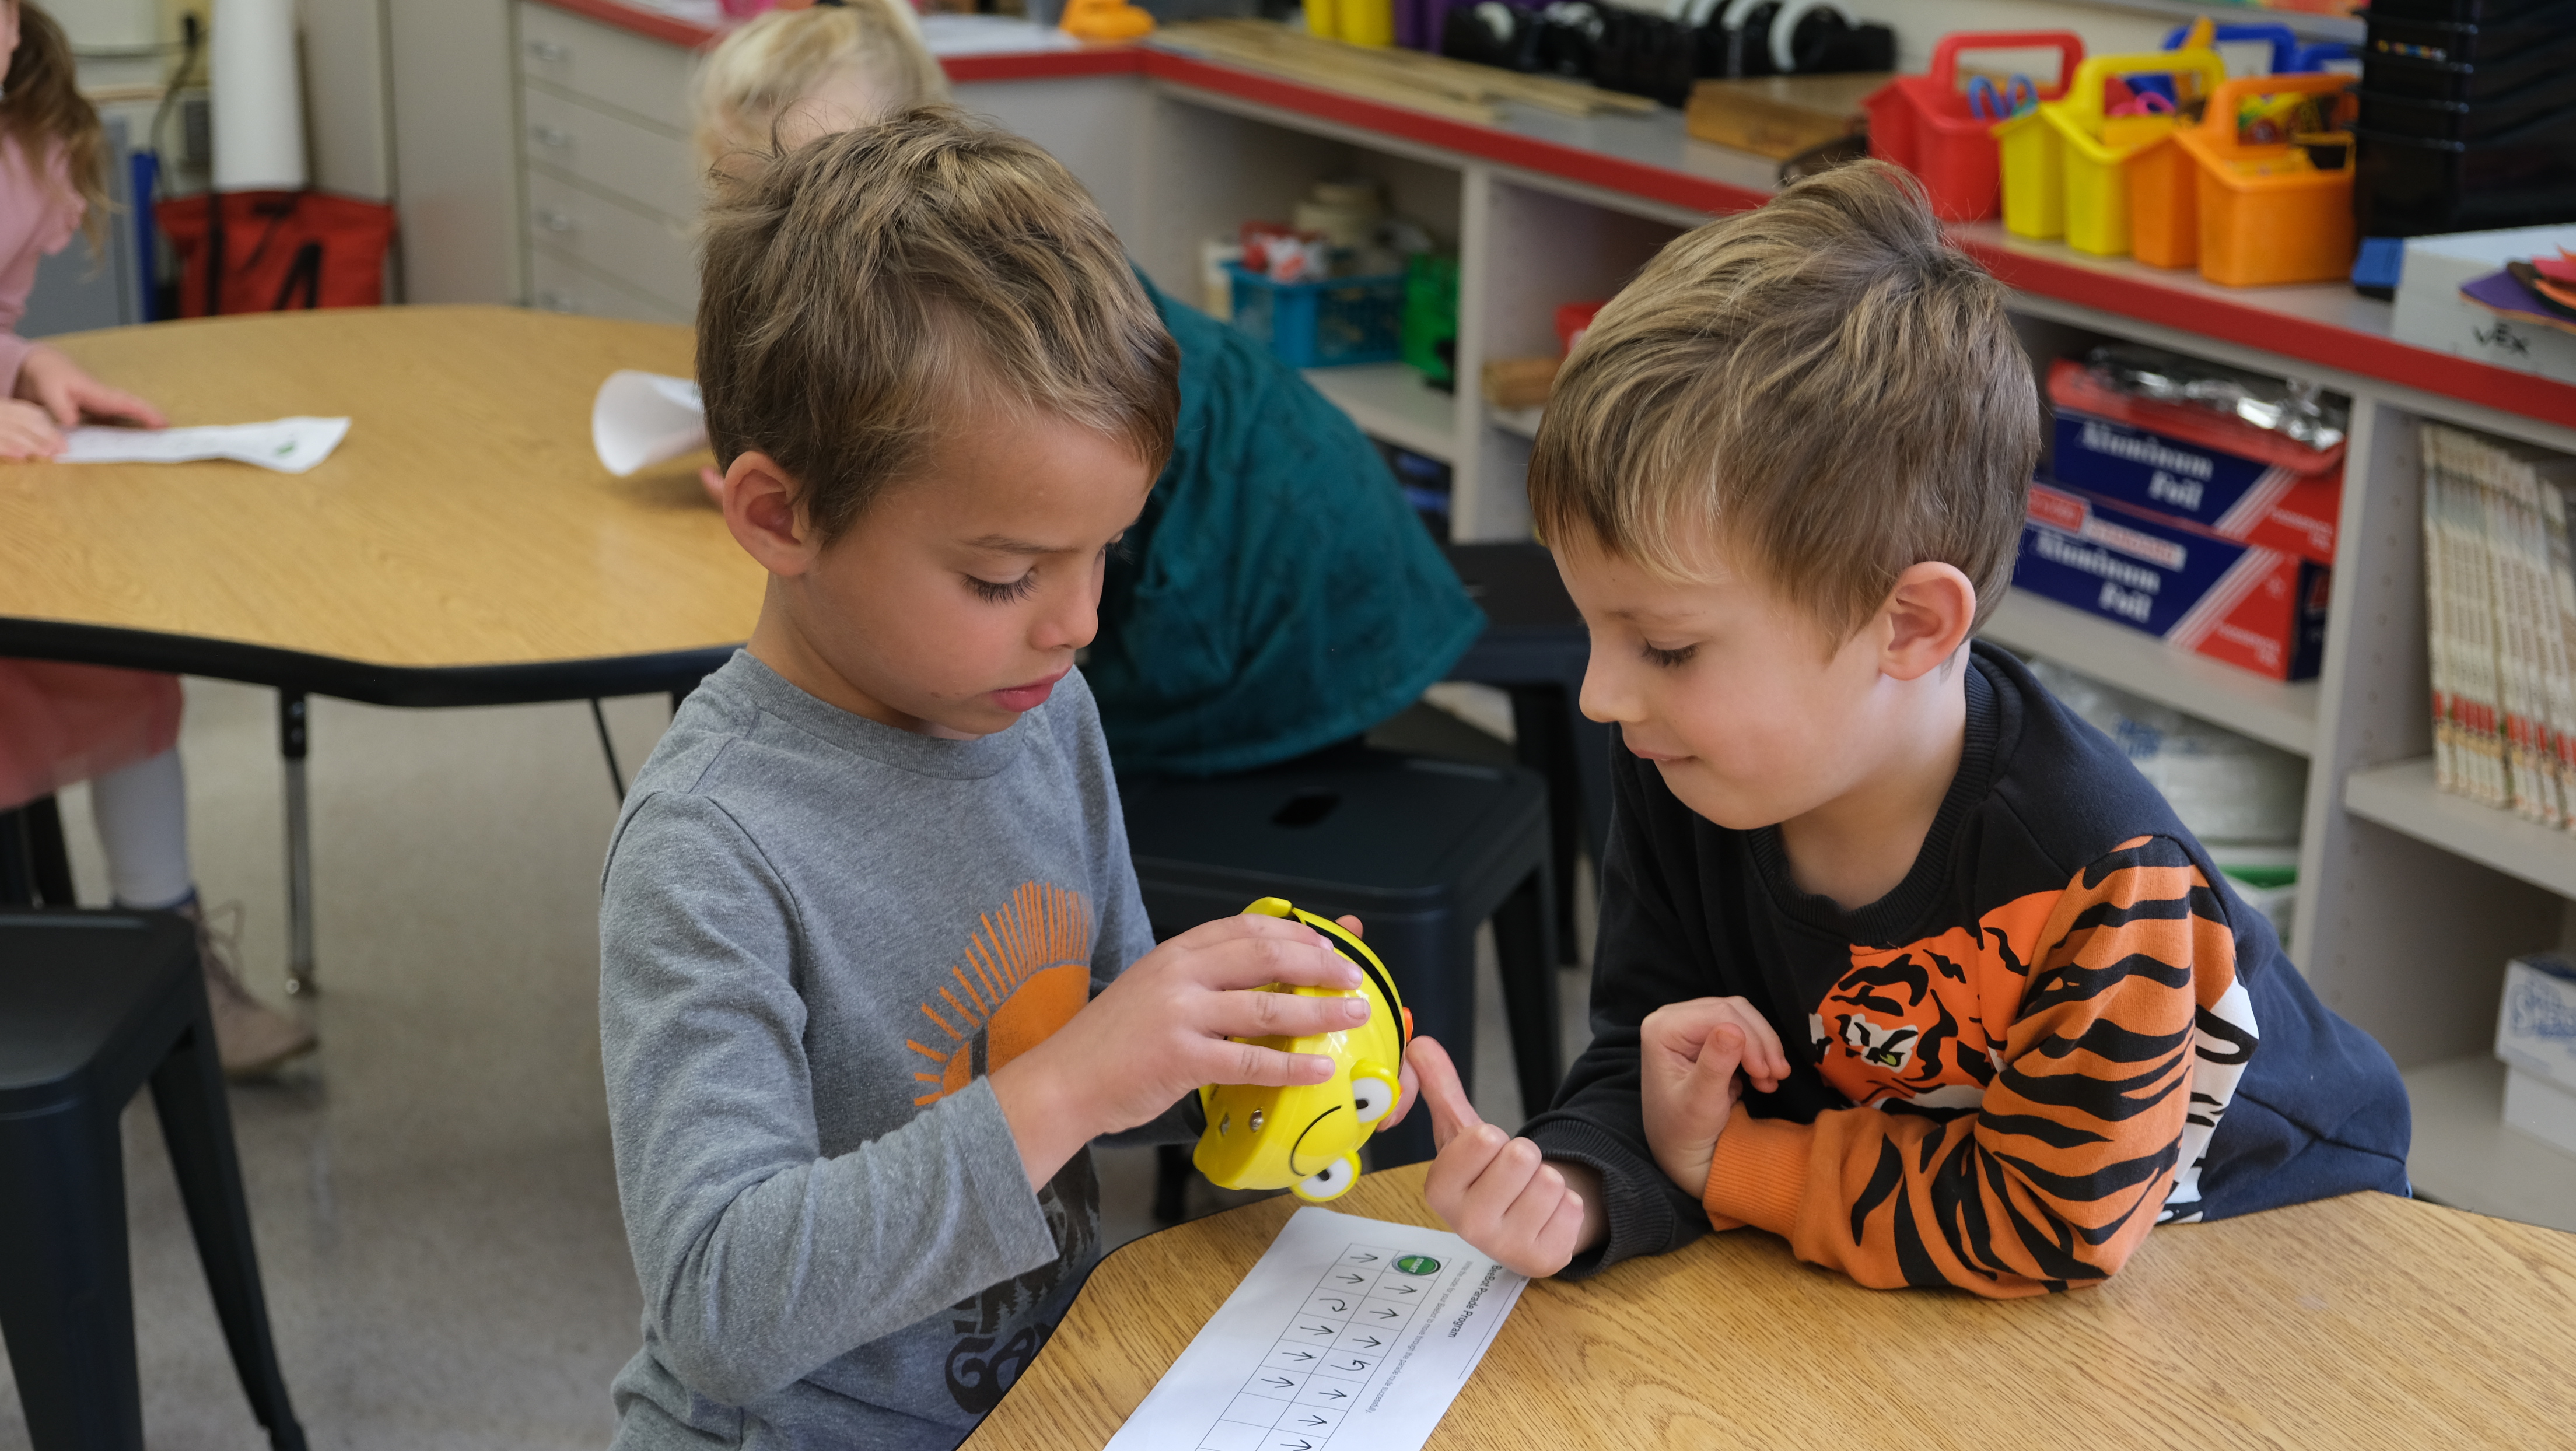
[0,307,762,699]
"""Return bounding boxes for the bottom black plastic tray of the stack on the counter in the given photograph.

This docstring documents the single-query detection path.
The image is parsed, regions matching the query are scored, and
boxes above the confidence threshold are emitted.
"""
[2352,108,2576,237]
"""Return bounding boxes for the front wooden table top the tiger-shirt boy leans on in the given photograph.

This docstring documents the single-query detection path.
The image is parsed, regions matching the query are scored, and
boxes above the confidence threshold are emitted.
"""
[966,1165,2576,1451]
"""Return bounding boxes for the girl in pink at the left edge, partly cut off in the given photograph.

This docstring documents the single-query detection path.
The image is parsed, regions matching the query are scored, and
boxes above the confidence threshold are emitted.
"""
[0,0,314,1077]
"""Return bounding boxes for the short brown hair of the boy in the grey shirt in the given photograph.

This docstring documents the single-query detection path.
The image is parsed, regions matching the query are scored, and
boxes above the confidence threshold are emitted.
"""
[698,106,1180,541]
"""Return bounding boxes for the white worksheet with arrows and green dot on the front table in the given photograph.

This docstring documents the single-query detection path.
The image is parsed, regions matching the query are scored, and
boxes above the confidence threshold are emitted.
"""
[1108,1206,1530,1451]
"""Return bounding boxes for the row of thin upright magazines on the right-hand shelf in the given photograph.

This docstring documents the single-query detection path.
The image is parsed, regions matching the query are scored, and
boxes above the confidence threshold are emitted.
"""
[2421,423,2576,830]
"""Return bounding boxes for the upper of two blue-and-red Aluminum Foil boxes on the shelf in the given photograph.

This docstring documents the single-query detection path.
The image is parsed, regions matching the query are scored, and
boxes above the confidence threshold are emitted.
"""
[2048,358,2344,565]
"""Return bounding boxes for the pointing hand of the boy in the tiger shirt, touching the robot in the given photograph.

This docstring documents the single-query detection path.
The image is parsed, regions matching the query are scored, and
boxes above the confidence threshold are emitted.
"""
[1406,1036,1584,1278]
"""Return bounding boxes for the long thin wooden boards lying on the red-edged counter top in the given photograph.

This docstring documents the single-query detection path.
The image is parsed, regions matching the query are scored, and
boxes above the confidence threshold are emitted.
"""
[1154,20,1656,127]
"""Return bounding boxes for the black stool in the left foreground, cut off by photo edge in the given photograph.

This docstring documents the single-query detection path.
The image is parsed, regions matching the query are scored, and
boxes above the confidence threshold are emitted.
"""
[0,912,304,1451]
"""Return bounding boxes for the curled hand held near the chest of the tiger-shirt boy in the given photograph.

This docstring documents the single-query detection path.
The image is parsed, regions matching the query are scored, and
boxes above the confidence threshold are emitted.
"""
[1639,997,1788,1198]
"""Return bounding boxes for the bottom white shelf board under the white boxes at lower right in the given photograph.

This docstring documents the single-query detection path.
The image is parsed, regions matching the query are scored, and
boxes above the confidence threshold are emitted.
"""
[2406,1054,2576,1229]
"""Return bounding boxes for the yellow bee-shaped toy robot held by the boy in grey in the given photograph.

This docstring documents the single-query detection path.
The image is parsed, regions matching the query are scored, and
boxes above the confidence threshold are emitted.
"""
[1190,897,1414,1204]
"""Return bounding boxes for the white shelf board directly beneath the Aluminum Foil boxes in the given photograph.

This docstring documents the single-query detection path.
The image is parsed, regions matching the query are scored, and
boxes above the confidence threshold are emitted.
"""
[1983,590,2329,763]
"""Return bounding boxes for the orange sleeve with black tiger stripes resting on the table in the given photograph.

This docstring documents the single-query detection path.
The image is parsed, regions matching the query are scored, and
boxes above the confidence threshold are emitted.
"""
[1703,837,2236,1299]
